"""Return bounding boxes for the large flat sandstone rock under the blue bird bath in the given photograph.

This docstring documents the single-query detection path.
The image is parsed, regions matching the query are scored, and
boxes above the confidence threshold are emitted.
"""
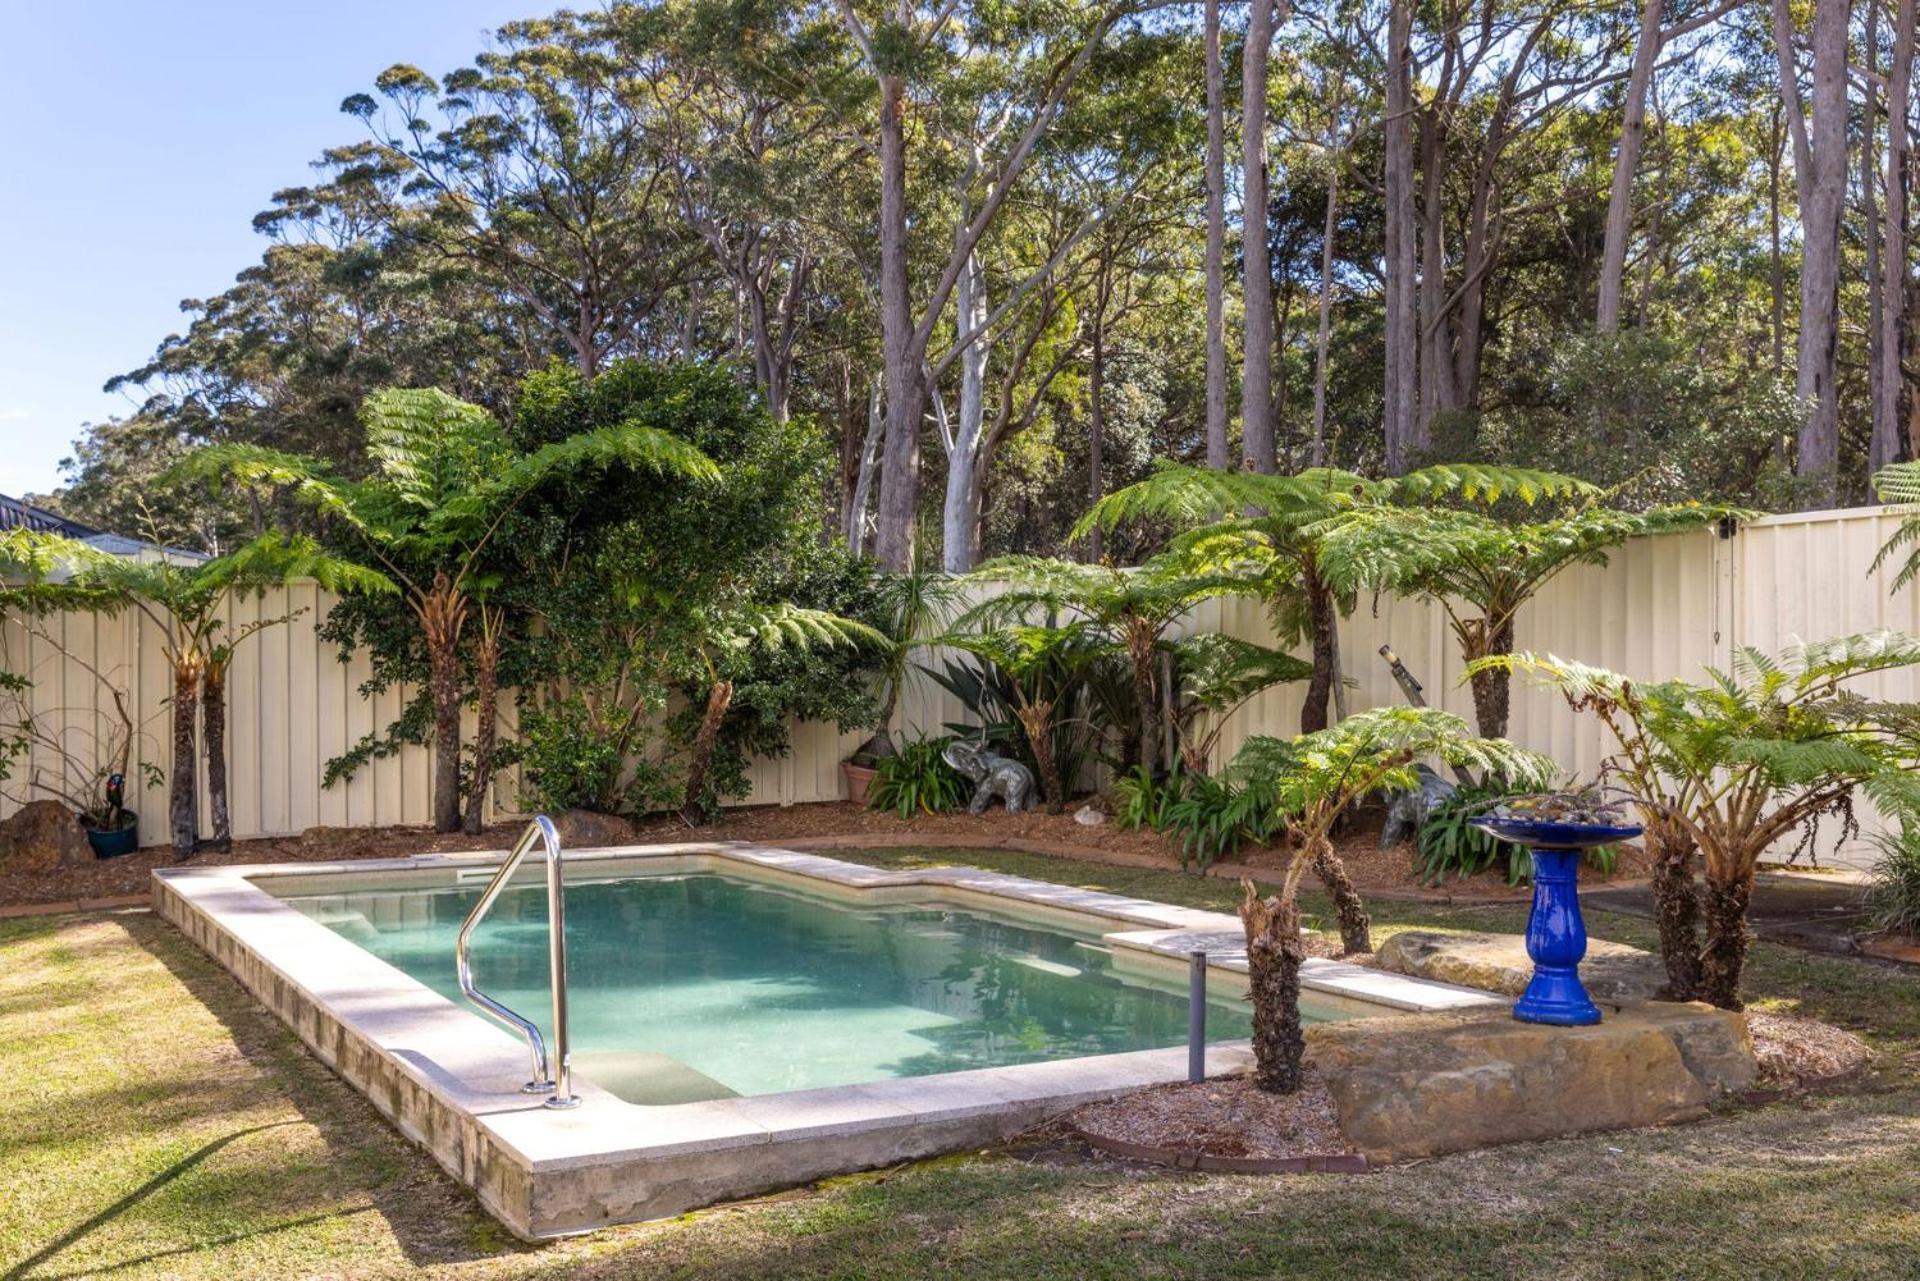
[1308,1003,1757,1160]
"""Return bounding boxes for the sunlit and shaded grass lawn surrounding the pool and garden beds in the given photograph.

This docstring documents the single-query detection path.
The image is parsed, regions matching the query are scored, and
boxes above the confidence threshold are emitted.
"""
[0,851,1920,1281]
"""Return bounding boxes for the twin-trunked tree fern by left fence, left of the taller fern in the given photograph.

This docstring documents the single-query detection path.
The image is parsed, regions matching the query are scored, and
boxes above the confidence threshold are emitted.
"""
[73,532,394,858]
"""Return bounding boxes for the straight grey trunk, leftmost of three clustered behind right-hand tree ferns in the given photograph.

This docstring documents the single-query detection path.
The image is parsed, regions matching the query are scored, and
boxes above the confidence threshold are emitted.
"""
[1384,0,1419,476]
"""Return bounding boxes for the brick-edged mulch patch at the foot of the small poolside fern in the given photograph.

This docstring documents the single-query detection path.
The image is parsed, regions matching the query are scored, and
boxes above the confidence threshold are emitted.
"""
[1066,1070,1367,1173]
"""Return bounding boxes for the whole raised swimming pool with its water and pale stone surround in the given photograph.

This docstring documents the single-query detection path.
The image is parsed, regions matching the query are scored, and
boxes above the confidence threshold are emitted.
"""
[154,843,1496,1241]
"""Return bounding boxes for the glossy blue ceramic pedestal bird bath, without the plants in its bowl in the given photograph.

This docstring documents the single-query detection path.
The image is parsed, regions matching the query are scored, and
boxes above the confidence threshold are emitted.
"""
[1473,814,1640,1027]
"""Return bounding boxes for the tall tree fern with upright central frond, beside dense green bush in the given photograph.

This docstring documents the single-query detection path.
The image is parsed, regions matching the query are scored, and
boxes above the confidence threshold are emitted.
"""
[188,388,718,832]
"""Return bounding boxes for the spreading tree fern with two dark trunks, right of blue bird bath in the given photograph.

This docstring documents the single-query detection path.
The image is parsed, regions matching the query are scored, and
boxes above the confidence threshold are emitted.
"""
[1476,632,1920,1010]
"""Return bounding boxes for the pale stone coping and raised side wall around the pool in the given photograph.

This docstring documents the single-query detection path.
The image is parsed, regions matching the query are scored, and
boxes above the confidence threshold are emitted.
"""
[152,841,1498,1241]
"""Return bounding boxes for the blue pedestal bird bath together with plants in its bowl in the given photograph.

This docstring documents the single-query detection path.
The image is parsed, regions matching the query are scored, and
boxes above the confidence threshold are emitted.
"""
[1475,789,1640,1027]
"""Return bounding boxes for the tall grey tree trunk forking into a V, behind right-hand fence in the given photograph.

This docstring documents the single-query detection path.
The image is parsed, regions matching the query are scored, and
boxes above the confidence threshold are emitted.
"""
[1774,0,1853,505]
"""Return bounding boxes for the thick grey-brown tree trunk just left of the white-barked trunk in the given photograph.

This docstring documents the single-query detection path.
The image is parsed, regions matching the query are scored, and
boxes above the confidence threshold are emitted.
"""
[874,75,925,570]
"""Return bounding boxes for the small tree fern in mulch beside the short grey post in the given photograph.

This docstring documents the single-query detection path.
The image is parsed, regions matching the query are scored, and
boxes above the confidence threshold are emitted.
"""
[1227,707,1557,1095]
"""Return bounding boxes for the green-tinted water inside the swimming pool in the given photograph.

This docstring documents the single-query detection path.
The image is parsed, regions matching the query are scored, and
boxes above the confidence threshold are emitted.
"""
[288,874,1274,1102]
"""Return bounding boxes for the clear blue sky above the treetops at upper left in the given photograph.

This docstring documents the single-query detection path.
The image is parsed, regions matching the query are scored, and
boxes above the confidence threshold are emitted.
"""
[0,0,533,494]
